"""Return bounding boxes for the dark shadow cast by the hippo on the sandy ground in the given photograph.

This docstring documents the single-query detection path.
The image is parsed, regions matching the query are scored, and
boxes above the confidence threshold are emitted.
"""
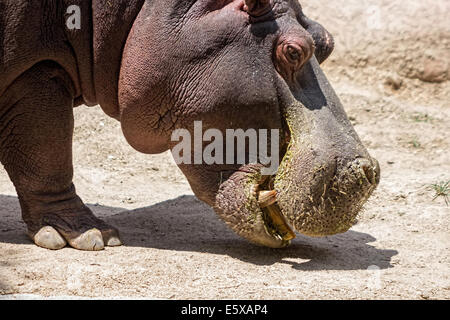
[0,195,398,271]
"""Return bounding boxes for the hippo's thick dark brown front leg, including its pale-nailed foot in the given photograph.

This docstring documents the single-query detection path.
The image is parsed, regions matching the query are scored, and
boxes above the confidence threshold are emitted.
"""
[0,62,121,250]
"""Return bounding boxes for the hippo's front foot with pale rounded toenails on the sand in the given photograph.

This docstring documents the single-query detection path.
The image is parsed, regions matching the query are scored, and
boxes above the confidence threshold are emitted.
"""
[28,208,122,251]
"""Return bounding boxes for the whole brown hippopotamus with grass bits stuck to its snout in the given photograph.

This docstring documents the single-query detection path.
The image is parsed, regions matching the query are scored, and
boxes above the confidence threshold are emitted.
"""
[0,0,380,251]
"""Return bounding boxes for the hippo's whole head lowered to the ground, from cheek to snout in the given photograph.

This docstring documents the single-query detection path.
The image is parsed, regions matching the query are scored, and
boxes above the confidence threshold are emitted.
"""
[119,0,380,247]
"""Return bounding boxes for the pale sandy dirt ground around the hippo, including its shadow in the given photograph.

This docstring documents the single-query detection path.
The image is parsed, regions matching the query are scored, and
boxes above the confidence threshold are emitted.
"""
[0,0,450,299]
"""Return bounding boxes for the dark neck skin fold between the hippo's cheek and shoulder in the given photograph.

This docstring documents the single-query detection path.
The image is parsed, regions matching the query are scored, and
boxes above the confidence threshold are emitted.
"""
[92,0,145,119]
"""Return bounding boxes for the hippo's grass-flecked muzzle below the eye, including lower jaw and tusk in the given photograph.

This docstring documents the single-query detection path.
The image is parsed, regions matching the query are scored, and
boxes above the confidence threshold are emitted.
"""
[215,57,380,247]
